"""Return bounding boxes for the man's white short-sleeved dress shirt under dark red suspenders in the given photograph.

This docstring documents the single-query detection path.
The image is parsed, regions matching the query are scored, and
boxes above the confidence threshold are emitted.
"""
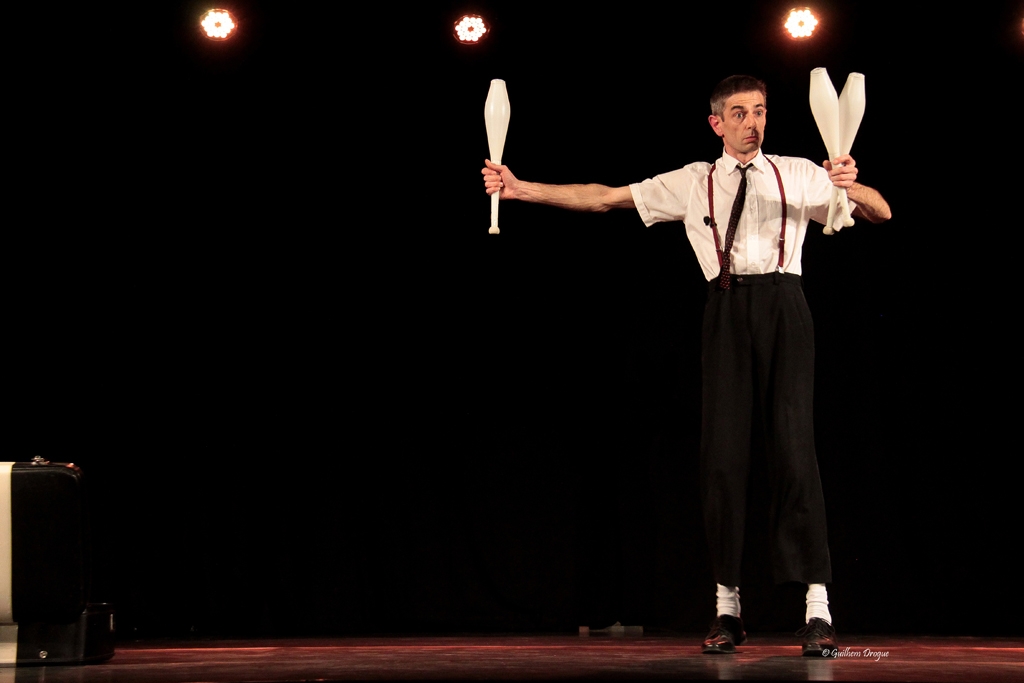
[630,151,855,281]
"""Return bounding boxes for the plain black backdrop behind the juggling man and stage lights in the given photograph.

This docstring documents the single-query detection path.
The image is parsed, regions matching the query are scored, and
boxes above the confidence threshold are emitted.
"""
[4,2,1024,638]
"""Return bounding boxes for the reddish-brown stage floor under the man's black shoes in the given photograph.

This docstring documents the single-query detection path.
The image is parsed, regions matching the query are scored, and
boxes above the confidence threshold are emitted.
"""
[0,634,1024,683]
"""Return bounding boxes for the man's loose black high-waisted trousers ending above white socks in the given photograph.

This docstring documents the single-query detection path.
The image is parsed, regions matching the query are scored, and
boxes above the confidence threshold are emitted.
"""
[700,273,831,586]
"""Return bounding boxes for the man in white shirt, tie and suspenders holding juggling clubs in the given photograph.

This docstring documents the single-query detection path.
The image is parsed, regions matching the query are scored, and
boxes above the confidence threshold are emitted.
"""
[481,76,890,656]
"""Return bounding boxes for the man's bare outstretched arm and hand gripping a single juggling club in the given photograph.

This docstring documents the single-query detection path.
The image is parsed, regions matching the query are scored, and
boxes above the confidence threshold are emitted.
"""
[480,159,636,212]
